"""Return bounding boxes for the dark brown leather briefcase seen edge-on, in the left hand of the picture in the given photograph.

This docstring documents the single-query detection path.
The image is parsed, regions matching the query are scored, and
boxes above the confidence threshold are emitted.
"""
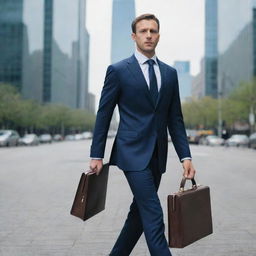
[70,164,109,221]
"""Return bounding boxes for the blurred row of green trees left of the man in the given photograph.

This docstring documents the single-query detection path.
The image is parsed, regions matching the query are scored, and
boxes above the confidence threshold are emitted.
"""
[0,84,95,135]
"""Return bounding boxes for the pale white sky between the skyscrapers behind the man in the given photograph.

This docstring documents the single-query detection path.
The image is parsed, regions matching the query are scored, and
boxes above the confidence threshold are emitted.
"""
[86,0,205,103]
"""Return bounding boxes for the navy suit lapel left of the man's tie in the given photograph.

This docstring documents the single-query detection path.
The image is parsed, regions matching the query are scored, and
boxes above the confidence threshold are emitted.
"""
[127,55,155,107]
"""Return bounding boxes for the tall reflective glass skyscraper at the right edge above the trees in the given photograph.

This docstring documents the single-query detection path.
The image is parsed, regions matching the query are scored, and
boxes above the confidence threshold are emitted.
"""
[204,0,256,97]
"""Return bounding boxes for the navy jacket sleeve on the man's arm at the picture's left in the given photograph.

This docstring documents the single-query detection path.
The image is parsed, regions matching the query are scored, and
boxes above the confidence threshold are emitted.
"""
[90,65,120,158]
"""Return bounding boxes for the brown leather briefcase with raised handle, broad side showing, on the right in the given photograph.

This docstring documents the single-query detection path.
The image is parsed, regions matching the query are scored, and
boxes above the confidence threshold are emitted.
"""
[167,178,212,248]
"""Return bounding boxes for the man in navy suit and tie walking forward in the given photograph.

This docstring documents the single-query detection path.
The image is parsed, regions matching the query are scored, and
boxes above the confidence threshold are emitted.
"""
[90,14,195,256]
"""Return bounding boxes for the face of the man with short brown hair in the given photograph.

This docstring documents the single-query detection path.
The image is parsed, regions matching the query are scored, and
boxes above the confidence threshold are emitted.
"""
[132,20,160,58]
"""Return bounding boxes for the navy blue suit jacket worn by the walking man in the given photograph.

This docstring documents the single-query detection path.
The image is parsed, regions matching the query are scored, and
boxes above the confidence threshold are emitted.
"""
[91,55,191,172]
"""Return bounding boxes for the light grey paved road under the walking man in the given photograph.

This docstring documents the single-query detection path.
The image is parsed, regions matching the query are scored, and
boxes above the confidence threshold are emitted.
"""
[0,141,256,256]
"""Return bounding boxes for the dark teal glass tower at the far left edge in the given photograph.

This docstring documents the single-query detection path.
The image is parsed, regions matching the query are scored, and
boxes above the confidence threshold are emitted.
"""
[0,0,27,90]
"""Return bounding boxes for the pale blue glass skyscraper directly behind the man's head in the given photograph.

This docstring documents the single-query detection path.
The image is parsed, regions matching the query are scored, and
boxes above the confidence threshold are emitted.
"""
[111,0,135,63]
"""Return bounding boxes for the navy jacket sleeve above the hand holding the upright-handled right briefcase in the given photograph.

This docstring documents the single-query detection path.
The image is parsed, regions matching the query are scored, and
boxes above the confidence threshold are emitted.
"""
[168,68,191,160]
